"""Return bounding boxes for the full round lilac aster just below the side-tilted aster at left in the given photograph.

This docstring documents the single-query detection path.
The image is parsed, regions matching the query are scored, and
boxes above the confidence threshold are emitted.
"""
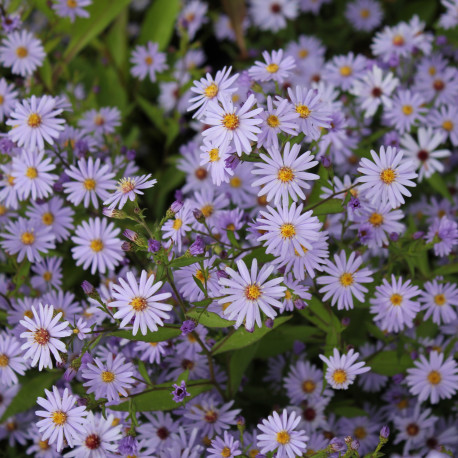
[72,218,123,274]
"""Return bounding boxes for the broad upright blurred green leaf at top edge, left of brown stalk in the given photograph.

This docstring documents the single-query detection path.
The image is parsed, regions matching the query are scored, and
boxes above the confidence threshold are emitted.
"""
[139,0,180,50]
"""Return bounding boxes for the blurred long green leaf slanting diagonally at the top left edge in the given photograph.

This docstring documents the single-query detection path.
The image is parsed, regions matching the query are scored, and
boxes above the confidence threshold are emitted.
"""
[63,0,130,62]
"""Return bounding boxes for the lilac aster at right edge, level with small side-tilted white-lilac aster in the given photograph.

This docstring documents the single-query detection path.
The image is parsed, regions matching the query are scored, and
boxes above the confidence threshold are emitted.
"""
[406,351,458,404]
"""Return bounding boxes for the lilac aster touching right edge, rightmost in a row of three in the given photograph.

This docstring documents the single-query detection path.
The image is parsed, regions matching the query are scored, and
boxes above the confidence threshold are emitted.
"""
[419,278,458,325]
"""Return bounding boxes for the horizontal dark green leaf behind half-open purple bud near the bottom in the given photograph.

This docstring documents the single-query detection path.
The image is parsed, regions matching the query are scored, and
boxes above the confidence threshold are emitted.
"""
[110,380,214,412]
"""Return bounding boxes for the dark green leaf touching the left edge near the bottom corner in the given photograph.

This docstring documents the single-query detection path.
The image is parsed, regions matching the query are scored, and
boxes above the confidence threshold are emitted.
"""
[0,371,62,422]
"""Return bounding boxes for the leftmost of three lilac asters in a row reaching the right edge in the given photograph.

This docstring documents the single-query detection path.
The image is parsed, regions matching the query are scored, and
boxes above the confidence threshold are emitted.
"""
[317,251,373,310]
